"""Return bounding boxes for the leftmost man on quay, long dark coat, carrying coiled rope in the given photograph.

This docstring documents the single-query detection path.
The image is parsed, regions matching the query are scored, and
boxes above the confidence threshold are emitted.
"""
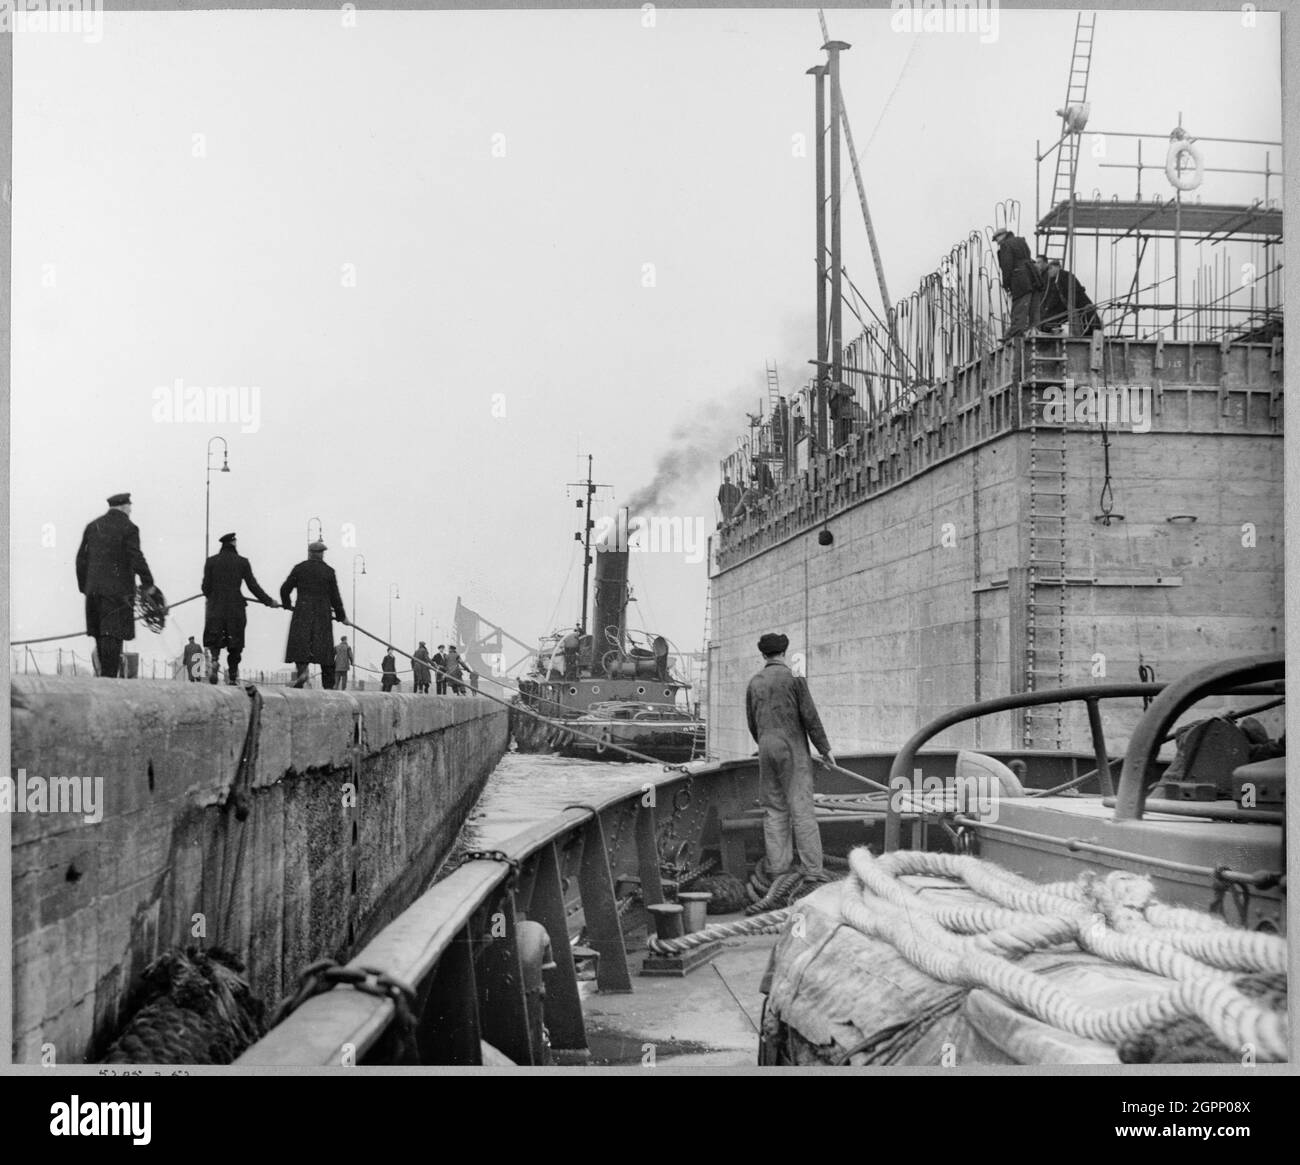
[77,494,153,679]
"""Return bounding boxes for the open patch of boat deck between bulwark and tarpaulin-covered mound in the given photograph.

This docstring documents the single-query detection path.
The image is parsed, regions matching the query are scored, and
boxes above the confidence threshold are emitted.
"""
[581,914,776,1067]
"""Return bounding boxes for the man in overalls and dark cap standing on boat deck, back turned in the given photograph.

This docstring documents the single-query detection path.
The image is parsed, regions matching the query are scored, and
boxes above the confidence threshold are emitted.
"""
[745,632,835,879]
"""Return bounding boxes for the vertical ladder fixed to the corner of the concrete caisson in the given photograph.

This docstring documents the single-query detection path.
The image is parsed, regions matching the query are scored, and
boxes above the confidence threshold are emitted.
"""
[1024,333,1070,748]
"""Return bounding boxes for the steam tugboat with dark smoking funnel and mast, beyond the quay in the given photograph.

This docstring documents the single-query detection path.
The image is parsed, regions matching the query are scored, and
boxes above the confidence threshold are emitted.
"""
[511,458,705,763]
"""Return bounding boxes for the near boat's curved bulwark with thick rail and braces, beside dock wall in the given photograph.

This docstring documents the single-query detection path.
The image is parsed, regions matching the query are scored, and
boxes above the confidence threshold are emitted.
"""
[238,771,693,1067]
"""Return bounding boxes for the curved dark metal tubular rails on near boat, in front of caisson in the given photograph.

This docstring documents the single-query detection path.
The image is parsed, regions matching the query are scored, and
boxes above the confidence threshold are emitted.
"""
[885,653,1284,850]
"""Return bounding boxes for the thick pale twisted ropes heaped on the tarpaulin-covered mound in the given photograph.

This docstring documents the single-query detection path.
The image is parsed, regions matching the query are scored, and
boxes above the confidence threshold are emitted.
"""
[841,849,1288,1062]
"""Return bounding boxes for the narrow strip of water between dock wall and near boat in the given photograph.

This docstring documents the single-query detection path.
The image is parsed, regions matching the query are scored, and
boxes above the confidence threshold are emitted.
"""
[437,753,663,878]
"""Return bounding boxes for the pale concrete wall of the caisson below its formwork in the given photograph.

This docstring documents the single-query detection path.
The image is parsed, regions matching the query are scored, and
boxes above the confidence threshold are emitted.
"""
[709,387,1284,758]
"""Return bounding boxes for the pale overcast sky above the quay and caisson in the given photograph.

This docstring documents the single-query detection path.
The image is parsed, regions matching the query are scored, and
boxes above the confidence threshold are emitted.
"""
[10,7,1281,670]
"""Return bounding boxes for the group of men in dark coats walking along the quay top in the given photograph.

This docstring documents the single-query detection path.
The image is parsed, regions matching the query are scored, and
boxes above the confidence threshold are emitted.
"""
[77,493,478,696]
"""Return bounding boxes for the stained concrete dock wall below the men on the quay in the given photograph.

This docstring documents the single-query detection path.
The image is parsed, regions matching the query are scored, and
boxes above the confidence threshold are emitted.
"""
[5,676,508,1064]
